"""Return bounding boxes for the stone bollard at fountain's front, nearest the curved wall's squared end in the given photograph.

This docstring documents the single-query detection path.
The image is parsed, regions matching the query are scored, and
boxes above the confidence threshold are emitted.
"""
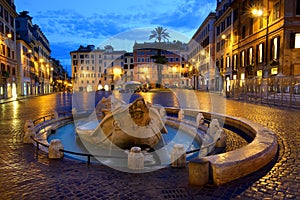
[171,144,186,168]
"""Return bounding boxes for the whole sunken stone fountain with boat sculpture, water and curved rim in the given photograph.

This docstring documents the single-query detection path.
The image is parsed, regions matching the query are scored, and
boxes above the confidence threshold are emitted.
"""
[29,91,278,185]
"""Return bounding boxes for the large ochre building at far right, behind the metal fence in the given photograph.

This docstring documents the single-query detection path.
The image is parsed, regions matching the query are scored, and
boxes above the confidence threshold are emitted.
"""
[230,0,300,96]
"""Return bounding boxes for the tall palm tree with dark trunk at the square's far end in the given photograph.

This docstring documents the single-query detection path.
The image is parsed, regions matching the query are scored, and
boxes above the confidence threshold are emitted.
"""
[149,26,170,86]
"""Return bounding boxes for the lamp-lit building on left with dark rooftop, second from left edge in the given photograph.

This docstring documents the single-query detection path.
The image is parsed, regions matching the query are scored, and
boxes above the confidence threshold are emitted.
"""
[15,11,52,95]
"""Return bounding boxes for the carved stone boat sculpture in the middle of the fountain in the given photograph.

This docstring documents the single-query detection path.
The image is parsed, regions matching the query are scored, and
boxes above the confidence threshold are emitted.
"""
[76,98,167,149]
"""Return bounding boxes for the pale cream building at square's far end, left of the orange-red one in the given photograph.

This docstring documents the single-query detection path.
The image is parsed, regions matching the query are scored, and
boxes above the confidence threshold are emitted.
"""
[70,45,126,92]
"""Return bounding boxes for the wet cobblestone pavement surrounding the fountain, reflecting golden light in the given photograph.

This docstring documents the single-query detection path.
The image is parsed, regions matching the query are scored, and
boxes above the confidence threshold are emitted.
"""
[0,93,300,199]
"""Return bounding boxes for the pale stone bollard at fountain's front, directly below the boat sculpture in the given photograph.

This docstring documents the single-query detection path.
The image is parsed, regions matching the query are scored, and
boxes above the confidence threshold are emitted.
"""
[128,147,145,169]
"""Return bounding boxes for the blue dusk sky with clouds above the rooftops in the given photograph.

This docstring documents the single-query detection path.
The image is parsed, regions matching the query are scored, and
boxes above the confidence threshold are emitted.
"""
[15,0,216,75]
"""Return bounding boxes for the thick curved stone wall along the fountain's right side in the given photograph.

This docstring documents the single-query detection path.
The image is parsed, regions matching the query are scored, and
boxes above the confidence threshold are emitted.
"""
[188,112,278,186]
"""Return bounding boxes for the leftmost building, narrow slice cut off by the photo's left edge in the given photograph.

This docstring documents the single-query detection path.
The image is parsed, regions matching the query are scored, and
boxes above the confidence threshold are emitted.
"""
[0,0,17,99]
